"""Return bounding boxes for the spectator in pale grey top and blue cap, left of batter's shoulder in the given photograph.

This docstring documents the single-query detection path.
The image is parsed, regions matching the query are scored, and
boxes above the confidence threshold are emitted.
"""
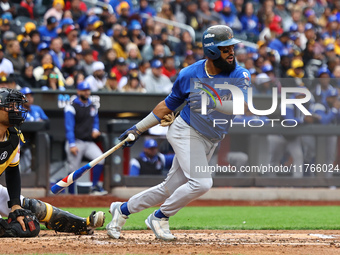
[142,59,172,93]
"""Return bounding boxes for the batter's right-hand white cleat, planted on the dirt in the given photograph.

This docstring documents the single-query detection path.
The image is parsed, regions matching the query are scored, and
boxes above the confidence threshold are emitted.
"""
[145,211,176,241]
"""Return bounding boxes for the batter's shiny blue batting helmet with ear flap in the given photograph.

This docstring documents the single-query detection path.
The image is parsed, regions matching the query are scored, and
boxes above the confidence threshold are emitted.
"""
[202,25,241,60]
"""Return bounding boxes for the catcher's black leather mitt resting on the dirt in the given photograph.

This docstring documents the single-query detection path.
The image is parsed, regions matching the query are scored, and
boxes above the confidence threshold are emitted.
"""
[2,209,40,237]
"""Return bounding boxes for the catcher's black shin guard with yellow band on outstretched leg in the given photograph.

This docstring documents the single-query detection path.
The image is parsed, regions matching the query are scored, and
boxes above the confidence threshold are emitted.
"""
[23,198,93,235]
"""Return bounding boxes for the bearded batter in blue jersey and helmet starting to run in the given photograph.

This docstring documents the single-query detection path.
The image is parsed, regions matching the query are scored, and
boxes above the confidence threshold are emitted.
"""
[106,25,250,241]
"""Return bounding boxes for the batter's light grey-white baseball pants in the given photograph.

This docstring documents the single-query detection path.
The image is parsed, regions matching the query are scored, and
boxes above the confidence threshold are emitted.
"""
[128,116,217,217]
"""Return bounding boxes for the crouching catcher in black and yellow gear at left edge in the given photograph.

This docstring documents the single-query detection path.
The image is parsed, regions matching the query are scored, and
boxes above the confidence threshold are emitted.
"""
[0,88,105,237]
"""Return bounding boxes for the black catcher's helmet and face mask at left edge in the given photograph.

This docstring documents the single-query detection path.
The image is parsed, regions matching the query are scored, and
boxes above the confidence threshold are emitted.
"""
[0,88,27,126]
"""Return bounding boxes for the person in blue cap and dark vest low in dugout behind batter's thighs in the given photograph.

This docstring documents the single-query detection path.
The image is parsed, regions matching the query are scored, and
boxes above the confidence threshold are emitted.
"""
[129,139,174,176]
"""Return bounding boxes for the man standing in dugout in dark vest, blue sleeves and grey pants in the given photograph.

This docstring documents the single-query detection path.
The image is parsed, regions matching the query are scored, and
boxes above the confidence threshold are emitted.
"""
[64,82,107,195]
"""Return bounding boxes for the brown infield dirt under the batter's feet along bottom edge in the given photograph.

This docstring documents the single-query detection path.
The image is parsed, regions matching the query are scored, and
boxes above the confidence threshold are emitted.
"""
[0,230,340,255]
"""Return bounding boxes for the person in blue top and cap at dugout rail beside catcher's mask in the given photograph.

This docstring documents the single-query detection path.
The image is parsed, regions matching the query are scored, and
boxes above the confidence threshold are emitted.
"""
[20,87,49,173]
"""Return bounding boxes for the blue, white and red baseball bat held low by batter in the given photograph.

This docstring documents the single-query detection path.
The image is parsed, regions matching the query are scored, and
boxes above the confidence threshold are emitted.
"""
[51,134,135,194]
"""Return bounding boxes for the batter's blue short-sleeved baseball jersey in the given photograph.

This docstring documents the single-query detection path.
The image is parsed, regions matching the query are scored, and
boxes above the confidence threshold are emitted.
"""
[165,59,251,140]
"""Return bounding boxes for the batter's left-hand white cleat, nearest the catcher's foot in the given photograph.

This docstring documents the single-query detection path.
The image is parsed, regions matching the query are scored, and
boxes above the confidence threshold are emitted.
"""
[106,202,129,239]
